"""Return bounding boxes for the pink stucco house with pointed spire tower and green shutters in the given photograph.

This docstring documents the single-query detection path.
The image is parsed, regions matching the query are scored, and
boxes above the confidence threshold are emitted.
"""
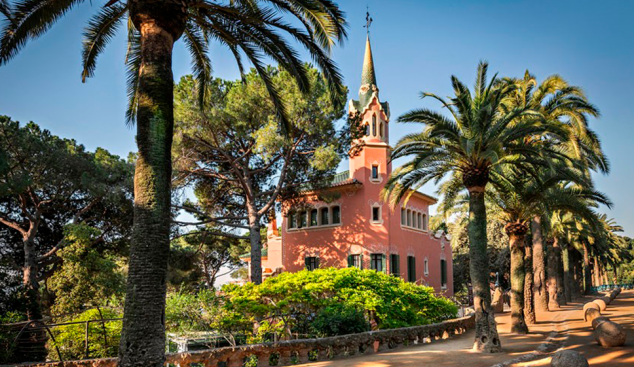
[245,38,453,296]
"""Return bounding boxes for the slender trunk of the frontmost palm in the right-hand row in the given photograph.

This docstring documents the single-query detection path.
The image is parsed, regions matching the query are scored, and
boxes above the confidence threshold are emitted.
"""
[467,188,502,353]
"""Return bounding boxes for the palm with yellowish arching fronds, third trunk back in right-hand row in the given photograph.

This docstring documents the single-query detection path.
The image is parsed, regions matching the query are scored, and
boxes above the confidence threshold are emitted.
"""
[498,70,609,311]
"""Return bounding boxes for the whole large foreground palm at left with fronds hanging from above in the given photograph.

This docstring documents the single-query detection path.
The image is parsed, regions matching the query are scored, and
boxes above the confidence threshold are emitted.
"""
[0,0,346,367]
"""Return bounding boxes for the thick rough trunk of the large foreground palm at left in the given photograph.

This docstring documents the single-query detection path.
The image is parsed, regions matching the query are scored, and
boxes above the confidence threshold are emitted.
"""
[119,0,186,367]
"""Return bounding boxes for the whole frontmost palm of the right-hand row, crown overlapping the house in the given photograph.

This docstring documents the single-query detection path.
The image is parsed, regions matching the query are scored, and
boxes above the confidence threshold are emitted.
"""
[382,63,565,352]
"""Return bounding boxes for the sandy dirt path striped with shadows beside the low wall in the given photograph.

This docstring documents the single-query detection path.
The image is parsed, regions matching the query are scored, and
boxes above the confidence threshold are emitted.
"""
[299,291,634,367]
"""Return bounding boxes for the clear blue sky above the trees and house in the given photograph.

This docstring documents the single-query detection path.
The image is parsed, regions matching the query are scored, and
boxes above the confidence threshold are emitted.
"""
[0,0,634,236]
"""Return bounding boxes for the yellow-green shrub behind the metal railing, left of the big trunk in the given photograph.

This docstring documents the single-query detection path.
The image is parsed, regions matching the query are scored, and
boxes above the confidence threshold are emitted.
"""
[46,309,122,360]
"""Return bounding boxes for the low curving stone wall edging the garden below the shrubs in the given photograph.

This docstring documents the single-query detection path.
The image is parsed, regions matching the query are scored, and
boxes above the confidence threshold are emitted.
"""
[14,315,475,367]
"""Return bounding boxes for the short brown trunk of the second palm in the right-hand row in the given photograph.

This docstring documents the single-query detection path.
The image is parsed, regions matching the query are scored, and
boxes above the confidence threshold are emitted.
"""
[507,229,528,334]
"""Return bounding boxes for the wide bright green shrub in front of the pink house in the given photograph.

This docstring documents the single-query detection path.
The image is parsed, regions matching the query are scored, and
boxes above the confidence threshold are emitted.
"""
[218,268,457,334]
